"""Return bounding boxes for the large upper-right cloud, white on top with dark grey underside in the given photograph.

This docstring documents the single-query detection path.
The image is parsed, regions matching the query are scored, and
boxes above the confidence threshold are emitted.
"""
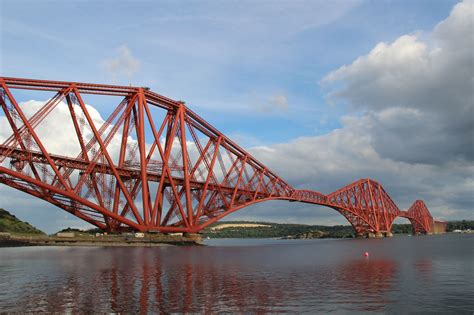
[322,1,474,164]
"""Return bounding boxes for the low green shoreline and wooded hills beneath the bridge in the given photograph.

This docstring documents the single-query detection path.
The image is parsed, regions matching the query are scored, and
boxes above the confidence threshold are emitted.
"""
[0,208,474,247]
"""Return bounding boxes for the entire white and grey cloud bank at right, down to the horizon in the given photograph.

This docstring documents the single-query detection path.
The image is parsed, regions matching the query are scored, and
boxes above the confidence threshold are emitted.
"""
[236,1,474,223]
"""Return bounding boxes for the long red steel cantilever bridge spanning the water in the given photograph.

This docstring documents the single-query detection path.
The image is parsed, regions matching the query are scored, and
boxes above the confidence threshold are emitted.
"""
[0,77,433,235]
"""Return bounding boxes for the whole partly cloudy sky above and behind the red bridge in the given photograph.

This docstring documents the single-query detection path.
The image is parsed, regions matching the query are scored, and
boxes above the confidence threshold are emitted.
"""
[0,0,474,232]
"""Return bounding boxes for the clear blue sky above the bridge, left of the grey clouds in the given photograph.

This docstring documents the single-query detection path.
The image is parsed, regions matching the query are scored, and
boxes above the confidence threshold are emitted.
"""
[1,0,454,144]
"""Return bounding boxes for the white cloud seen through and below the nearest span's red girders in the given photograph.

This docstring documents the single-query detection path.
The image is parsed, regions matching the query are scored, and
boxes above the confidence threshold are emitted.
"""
[0,100,237,232]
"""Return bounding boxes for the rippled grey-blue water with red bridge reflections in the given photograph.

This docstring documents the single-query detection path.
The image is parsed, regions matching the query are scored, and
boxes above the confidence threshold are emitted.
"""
[0,234,474,314]
